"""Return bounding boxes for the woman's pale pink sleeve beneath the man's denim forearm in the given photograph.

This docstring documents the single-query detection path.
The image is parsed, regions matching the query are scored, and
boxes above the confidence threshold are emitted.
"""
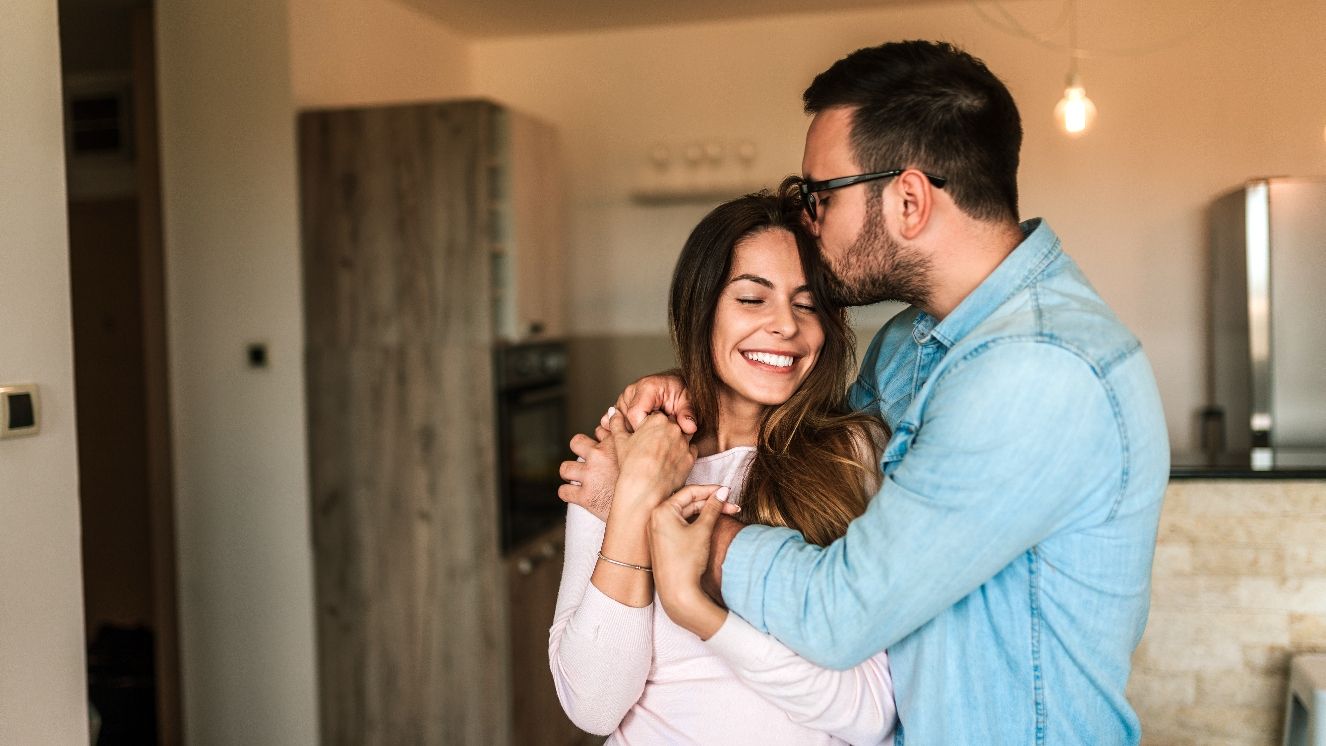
[705,613,896,746]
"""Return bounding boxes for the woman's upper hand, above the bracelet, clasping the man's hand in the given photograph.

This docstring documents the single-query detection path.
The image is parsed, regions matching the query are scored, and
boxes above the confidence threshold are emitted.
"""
[607,412,695,519]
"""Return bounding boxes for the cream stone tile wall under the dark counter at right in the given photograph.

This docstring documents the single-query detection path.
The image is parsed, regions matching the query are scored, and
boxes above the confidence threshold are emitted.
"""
[1128,480,1326,746]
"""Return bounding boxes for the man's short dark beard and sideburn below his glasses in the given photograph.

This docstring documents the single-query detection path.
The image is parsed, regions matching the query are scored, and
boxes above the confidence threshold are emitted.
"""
[821,196,931,306]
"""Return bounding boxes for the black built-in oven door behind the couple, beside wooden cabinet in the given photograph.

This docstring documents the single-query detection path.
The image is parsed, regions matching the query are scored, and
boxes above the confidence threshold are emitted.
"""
[499,383,570,551]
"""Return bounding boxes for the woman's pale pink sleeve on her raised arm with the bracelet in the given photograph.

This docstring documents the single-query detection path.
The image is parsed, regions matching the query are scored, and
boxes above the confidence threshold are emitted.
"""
[548,505,654,735]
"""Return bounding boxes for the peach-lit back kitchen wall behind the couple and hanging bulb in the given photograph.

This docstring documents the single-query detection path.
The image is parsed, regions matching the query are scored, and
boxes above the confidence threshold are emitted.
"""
[473,0,1326,448]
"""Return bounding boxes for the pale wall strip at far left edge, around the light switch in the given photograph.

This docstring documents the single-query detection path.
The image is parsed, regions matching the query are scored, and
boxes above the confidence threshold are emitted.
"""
[0,0,88,745]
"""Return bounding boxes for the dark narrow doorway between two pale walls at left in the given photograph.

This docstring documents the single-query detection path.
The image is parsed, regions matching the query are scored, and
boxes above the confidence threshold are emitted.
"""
[60,0,183,746]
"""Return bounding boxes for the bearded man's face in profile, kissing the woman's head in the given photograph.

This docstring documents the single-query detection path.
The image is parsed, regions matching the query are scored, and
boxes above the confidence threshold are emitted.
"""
[801,107,930,306]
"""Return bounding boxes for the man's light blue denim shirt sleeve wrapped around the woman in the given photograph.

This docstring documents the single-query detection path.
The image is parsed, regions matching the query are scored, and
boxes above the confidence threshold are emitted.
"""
[723,339,1124,668]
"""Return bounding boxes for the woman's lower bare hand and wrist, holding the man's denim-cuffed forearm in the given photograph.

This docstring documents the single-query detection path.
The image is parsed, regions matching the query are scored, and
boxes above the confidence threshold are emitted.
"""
[650,485,737,640]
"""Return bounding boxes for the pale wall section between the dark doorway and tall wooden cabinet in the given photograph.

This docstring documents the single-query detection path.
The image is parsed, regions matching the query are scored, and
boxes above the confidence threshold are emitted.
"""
[156,0,318,745]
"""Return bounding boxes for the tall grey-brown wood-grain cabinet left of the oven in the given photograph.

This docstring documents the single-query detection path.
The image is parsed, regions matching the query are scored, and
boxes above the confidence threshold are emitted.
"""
[298,101,561,746]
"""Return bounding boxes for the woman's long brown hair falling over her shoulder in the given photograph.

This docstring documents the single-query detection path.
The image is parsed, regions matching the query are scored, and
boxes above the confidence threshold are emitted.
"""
[668,178,883,546]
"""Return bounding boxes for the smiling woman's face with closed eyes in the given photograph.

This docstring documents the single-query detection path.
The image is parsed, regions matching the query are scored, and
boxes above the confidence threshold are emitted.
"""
[713,229,825,405]
